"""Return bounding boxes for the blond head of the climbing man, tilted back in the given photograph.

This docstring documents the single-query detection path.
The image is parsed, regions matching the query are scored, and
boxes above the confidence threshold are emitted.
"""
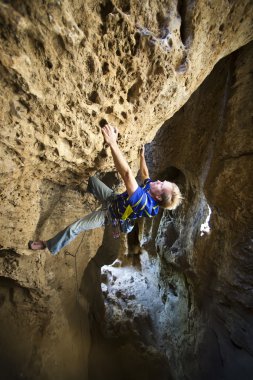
[150,181,183,210]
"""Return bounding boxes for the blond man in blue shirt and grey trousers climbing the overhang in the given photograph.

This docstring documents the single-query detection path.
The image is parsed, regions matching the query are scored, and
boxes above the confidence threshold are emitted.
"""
[28,124,182,255]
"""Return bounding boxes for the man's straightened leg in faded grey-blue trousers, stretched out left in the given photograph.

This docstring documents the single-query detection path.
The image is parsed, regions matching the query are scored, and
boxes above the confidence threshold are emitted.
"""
[30,210,106,255]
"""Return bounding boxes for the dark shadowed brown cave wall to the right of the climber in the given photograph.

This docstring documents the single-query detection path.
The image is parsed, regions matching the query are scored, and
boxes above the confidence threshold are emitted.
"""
[152,44,253,379]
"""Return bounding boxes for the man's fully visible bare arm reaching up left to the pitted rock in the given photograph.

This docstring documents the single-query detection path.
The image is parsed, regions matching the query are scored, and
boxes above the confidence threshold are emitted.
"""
[102,124,138,196]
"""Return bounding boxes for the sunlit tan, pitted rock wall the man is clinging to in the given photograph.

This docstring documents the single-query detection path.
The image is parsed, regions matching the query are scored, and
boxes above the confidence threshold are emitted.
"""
[0,0,253,380]
